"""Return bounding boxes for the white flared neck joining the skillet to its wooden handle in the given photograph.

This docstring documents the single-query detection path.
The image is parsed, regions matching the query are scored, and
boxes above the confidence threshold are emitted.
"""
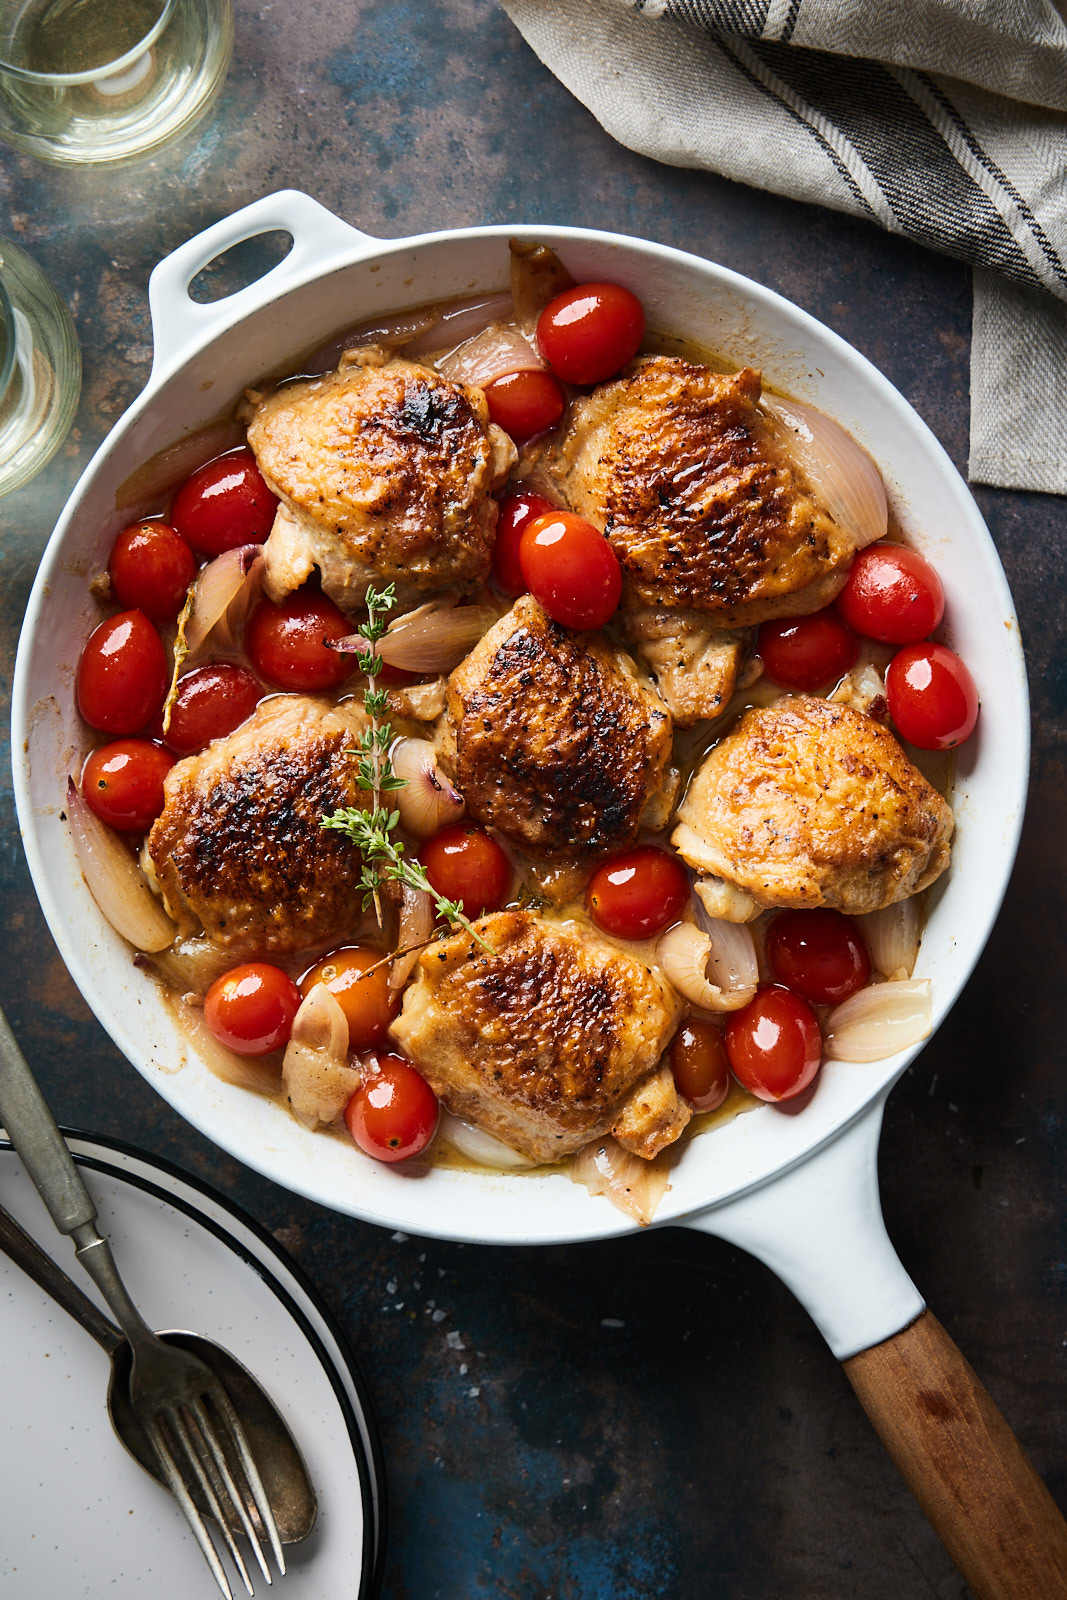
[685,1088,925,1362]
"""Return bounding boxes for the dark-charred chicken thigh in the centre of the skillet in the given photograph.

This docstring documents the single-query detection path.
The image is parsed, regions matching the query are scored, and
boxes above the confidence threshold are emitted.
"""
[438,595,677,861]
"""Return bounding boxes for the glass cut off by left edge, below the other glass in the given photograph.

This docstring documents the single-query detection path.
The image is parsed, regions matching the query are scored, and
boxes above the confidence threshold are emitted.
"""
[0,238,82,494]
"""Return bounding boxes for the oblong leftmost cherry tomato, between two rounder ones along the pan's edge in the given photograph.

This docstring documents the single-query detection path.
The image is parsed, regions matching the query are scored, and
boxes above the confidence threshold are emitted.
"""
[77,611,170,733]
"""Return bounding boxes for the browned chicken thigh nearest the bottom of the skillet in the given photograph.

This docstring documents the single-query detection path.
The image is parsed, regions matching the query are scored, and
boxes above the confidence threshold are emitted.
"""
[392,910,688,1162]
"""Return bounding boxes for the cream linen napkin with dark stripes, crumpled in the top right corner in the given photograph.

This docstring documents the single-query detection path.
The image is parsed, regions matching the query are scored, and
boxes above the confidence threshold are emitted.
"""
[502,0,1067,494]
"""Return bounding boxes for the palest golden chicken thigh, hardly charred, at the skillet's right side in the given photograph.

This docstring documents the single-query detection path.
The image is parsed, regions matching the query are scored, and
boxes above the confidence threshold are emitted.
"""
[672,694,953,922]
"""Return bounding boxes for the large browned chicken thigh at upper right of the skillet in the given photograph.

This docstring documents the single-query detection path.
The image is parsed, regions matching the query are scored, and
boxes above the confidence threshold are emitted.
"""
[542,355,856,723]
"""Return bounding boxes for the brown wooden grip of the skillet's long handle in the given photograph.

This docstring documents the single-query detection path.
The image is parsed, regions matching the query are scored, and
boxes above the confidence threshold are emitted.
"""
[841,1310,1067,1600]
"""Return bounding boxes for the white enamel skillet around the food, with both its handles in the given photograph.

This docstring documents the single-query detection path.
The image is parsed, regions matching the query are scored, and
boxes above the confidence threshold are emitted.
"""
[13,190,1067,1600]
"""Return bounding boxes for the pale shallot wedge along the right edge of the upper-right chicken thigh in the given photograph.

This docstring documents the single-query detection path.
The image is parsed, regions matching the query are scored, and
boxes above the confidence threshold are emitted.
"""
[763,395,888,550]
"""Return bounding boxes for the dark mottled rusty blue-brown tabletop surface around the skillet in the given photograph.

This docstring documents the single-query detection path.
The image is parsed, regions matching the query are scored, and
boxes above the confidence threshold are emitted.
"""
[0,0,1067,1600]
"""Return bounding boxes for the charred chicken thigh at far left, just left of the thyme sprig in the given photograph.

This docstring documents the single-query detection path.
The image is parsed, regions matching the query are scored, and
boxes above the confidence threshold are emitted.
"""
[149,694,365,958]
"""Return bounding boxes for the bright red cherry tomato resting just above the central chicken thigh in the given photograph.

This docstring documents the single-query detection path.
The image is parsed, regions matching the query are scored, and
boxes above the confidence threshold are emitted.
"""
[518,510,622,627]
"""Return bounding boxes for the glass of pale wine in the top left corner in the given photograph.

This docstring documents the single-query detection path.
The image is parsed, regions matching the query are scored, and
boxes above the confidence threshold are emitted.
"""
[0,0,234,166]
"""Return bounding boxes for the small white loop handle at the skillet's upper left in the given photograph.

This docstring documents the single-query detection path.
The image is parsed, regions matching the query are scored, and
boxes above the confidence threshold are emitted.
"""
[149,189,381,382]
